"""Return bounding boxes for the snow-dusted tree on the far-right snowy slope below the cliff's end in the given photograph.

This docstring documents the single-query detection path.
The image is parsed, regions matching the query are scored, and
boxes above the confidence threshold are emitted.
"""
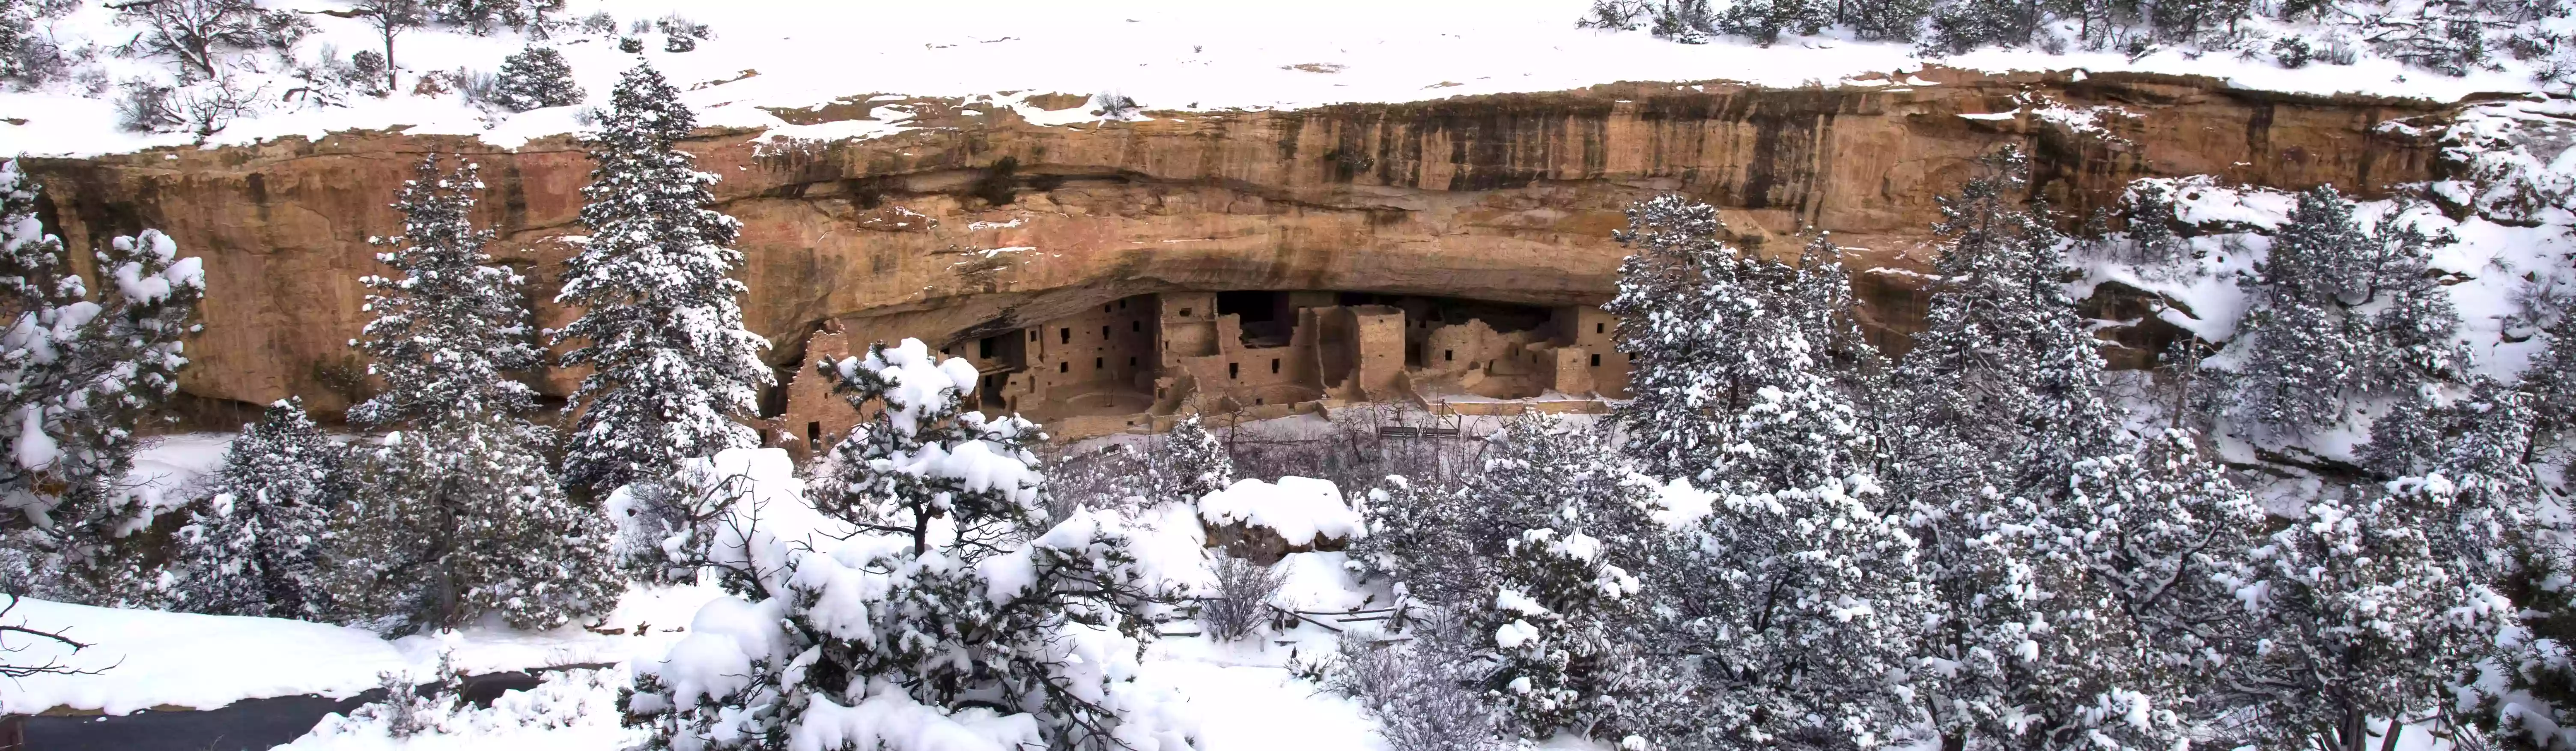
[2228,186,2465,436]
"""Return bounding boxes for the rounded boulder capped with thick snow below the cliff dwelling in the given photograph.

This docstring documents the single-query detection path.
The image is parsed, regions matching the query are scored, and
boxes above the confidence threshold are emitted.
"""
[1198,477,1368,563]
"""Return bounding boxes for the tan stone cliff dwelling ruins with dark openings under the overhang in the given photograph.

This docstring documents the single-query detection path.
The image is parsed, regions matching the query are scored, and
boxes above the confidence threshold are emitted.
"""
[770,289,1628,452]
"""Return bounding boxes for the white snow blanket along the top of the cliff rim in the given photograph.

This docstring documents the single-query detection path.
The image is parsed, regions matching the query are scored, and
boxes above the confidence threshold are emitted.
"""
[0,0,2532,155]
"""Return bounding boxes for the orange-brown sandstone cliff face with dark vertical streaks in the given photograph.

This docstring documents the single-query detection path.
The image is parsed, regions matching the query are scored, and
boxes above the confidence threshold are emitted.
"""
[28,72,2445,420]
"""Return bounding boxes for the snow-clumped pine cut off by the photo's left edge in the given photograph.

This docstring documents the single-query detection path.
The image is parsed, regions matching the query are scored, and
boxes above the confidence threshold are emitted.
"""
[0,160,206,604]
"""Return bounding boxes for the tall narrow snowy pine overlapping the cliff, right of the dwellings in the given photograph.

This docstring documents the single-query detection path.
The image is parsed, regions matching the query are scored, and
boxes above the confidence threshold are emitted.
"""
[1883,150,2177,743]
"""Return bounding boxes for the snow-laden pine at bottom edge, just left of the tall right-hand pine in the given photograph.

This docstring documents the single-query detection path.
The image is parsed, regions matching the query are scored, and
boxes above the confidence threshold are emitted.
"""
[1646,317,1932,748]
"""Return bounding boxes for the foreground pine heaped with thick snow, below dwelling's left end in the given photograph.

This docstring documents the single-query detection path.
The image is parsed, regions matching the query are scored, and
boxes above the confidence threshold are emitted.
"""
[626,341,1195,751]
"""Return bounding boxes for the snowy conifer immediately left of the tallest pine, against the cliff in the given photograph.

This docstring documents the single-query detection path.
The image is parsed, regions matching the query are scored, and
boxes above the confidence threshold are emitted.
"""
[327,155,621,627]
